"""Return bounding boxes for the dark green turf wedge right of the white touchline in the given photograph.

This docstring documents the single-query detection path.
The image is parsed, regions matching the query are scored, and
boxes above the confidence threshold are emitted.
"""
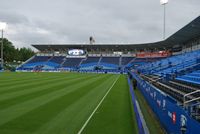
[82,76,137,134]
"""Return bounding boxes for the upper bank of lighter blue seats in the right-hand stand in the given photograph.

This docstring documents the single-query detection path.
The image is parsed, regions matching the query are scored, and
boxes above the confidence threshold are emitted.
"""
[138,50,200,75]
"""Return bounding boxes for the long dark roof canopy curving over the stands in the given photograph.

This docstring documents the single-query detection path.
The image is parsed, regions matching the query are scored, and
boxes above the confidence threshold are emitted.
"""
[32,16,200,51]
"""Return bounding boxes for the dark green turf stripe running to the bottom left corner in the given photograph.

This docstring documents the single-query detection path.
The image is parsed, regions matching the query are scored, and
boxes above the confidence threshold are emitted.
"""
[0,76,112,132]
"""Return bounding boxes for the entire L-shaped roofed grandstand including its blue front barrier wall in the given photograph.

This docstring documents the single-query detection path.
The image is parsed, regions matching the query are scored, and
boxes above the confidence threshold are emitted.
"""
[13,16,200,134]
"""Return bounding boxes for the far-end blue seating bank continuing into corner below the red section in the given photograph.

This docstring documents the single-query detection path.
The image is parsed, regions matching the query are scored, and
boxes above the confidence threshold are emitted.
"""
[17,56,152,71]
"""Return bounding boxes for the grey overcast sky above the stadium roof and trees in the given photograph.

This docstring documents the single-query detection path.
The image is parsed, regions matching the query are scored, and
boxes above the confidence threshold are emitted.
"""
[0,0,200,47]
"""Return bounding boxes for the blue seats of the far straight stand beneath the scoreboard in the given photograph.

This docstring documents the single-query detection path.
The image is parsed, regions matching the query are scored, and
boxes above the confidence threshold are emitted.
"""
[18,56,137,69]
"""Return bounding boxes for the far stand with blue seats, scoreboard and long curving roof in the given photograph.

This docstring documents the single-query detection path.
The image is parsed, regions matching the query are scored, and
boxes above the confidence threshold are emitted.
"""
[18,17,200,71]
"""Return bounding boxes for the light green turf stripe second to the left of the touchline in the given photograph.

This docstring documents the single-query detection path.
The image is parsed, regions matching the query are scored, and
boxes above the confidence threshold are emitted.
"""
[0,75,108,125]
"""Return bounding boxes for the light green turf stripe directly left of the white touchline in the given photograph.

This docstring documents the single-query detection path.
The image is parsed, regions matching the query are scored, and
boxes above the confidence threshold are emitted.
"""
[35,75,116,134]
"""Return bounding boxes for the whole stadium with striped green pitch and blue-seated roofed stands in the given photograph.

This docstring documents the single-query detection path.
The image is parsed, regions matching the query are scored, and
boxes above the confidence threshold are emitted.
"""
[0,0,200,134]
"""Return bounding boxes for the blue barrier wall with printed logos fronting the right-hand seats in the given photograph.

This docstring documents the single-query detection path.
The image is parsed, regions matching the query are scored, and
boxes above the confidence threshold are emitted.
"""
[129,72,200,134]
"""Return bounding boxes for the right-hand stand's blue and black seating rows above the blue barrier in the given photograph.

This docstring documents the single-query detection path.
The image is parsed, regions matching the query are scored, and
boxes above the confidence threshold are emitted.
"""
[135,50,200,121]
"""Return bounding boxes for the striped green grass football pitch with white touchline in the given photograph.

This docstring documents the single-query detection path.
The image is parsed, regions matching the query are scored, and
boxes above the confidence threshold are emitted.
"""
[0,73,138,134]
